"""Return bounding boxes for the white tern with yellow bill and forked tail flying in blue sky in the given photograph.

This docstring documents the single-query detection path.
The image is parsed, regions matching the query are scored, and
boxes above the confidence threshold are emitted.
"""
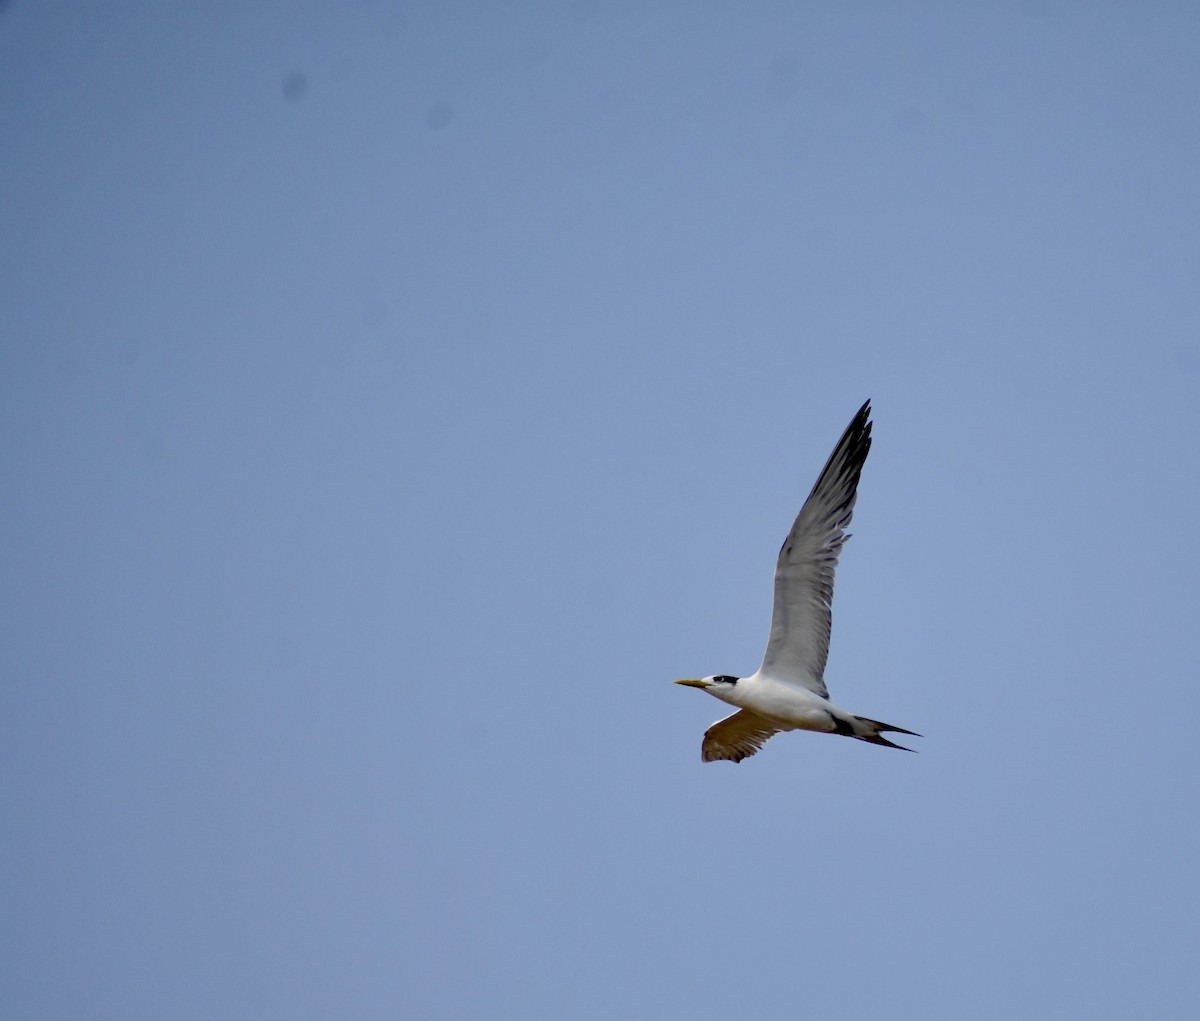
[676,401,920,762]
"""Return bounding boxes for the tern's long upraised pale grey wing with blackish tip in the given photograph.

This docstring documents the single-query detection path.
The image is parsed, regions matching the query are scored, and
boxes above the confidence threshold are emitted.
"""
[760,401,871,698]
